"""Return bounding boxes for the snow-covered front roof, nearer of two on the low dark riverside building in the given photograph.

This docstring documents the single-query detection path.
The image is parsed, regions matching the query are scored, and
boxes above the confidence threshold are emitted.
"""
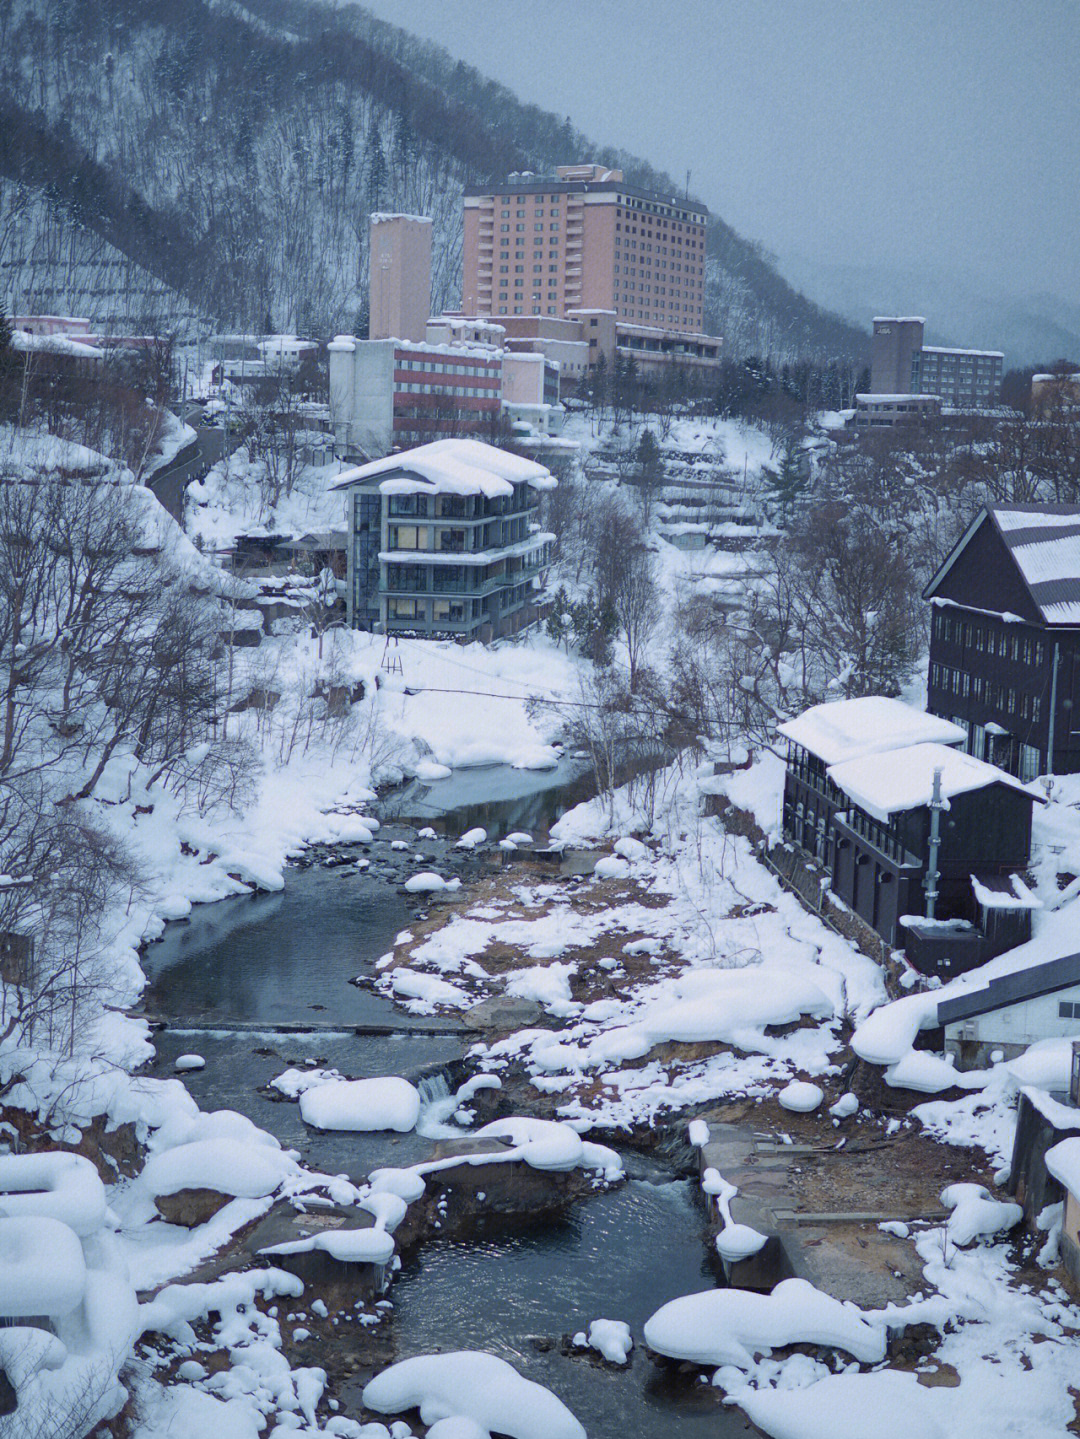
[828,744,1035,822]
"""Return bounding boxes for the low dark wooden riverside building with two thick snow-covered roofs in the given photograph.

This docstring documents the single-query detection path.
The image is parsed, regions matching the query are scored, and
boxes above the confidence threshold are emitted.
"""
[779,698,1035,976]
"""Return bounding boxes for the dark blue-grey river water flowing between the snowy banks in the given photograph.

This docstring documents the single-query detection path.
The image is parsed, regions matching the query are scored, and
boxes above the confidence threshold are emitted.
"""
[142,766,749,1439]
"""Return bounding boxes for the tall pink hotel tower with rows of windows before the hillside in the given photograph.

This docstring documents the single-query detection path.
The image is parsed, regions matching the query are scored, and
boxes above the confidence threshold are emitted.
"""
[462,165,709,334]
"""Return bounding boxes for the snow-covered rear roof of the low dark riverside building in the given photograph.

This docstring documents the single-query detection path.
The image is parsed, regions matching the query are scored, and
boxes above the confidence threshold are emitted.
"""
[777,695,966,764]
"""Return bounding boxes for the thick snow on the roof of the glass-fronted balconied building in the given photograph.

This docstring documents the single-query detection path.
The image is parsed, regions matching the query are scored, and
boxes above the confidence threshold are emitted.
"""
[332,439,557,498]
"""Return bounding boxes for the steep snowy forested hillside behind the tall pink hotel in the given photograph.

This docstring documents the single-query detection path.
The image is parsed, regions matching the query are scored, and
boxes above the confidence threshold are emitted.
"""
[0,0,866,361]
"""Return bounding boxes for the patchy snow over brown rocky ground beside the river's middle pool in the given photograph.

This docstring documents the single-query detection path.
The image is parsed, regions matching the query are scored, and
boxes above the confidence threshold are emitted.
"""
[378,771,884,1127]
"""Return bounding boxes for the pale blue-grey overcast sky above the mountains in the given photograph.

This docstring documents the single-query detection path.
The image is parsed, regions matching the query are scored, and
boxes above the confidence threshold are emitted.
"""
[350,0,1080,302]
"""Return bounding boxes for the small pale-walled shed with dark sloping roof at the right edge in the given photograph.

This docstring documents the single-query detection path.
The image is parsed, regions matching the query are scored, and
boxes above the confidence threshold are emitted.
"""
[938,954,1080,1069]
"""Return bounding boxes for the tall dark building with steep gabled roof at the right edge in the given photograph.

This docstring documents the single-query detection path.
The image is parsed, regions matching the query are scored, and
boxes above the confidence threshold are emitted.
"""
[925,505,1080,780]
